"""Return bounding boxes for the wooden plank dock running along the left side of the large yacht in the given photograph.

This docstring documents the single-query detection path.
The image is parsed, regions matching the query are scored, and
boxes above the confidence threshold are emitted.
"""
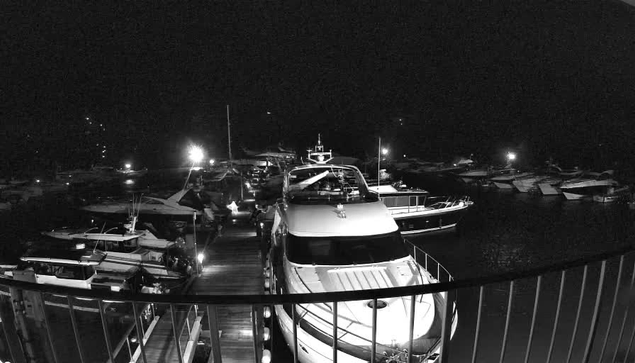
[139,223,264,363]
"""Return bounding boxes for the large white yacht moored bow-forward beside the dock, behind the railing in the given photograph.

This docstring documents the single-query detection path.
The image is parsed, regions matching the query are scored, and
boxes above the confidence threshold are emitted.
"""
[268,137,458,363]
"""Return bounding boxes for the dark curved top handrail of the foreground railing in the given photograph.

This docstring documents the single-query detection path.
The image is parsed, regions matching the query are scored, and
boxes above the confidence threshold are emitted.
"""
[0,245,635,305]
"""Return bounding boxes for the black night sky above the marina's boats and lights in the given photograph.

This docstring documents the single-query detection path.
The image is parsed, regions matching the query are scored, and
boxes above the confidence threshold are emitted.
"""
[0,0,635,171]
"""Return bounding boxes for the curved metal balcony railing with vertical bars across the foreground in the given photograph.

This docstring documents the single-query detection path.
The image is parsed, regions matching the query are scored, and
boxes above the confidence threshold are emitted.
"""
[0,247,635,363]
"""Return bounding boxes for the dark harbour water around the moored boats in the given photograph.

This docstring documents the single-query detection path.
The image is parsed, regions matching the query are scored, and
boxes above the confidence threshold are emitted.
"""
[0,171,635,362]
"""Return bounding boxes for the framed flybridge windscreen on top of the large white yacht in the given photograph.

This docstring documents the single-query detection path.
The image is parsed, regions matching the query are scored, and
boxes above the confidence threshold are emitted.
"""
[287,166,378,204]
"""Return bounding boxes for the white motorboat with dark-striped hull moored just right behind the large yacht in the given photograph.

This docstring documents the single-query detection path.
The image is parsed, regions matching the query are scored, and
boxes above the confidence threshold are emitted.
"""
[369,185,473,234]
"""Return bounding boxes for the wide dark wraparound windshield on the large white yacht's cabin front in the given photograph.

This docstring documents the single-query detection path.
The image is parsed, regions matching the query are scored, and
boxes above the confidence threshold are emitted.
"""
[287,232,409,265]
